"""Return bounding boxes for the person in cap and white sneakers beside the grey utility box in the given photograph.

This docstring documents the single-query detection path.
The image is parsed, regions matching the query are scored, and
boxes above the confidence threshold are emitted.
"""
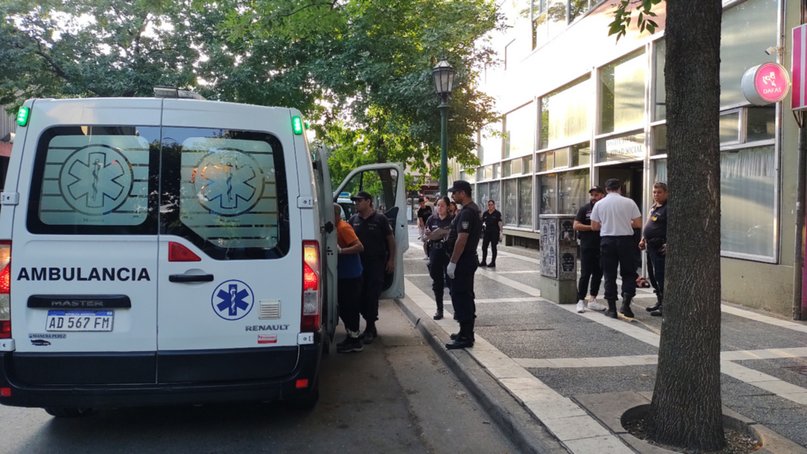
[573,186,605,314]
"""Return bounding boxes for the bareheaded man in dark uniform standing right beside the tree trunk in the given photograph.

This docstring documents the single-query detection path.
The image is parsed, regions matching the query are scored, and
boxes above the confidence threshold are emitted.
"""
[639,183,669,317]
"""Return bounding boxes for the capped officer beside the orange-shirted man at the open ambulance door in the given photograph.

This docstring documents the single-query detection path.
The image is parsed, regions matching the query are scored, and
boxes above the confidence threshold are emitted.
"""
[350,191,395,344]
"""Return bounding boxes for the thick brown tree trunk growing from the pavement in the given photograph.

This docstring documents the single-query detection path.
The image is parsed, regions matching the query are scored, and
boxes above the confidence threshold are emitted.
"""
[650,0,725,451]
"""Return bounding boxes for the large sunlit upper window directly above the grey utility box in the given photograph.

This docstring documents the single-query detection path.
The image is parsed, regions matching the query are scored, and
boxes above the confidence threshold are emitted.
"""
[539,80,592,149]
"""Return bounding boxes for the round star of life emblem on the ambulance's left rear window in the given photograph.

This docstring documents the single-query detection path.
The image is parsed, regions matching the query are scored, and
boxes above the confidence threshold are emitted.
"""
[59,145,133,215]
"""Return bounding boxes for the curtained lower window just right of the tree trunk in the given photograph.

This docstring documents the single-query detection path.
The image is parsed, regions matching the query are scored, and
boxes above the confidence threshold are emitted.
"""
[720,146,776,259]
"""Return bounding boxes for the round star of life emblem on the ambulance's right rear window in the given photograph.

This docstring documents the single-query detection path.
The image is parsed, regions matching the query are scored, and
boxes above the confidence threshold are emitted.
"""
[191,149,263,216]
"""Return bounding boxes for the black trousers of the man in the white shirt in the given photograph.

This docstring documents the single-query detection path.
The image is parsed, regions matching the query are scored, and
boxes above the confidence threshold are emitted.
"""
[600,235,638,301]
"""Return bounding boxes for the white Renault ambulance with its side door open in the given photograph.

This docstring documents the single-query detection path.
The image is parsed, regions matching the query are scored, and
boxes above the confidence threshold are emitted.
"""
[0,97,408,416]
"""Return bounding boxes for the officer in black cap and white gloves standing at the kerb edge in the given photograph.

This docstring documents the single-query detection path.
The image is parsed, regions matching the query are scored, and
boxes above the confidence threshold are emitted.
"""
[446,180,482,350]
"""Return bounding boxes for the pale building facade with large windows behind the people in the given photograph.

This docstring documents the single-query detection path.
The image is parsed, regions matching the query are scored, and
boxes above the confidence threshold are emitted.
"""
[468,0,807,317]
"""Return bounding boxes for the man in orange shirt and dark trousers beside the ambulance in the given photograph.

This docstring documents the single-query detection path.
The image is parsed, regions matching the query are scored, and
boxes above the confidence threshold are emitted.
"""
[333,204,364,353]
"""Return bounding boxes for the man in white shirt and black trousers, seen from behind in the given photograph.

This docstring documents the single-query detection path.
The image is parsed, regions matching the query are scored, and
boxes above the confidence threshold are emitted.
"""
[591,178,642,318]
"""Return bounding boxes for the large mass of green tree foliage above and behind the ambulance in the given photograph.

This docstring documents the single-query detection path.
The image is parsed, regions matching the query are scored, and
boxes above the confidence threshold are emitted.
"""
[0,0,500,184]
